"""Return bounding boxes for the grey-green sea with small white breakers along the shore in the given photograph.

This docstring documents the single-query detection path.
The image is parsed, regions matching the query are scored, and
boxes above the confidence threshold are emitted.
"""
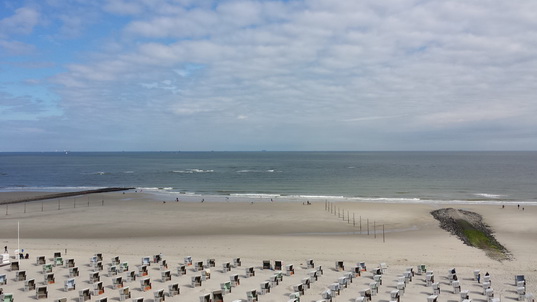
[0,151,537,205]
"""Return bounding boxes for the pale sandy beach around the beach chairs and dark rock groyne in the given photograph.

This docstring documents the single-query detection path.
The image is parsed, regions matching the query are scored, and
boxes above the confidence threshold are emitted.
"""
[0,191,537,302]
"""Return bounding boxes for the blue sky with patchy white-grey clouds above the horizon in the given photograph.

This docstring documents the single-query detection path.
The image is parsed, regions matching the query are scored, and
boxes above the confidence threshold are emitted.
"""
[0,0,537,152]
